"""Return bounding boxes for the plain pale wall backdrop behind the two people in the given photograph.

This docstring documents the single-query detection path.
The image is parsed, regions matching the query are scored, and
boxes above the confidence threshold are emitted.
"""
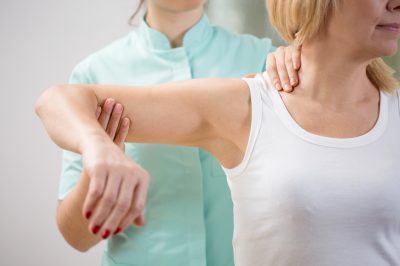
[0,0,396,266]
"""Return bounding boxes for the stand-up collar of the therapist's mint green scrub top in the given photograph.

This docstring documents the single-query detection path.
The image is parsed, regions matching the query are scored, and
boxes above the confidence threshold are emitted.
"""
[139,15,212,50]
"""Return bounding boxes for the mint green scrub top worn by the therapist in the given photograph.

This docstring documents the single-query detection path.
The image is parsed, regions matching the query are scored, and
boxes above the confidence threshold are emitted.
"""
[59,16,274,266]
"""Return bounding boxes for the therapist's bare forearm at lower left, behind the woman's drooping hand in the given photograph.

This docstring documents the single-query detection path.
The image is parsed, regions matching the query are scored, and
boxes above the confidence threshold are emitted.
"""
[57,172,101,252]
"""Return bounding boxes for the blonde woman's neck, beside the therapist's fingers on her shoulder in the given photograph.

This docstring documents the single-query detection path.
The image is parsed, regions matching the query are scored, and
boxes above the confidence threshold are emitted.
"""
[295,38,378,107]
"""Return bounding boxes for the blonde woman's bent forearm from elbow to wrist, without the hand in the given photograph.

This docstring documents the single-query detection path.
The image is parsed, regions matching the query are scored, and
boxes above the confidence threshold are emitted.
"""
[35,85,109,153]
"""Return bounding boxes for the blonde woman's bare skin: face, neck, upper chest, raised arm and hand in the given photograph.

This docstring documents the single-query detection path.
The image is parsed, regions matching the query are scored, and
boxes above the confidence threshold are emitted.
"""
[36,0,400,245]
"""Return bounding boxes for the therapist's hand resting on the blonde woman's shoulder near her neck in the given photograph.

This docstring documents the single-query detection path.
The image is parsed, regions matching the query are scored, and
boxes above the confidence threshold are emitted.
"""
[266,46,301,92]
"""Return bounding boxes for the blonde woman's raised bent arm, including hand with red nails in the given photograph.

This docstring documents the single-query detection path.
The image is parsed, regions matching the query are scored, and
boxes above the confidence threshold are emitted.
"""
[36,79,251,239]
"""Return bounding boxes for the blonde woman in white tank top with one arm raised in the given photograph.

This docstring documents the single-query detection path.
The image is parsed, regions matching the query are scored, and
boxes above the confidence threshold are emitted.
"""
[36,0,400,266]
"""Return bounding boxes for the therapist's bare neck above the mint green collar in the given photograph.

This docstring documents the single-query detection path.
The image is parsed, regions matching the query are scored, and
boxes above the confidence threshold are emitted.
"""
[146,1,204,48]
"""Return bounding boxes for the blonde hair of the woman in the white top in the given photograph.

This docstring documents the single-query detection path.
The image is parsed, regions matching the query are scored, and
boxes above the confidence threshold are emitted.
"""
[267,0,399,93]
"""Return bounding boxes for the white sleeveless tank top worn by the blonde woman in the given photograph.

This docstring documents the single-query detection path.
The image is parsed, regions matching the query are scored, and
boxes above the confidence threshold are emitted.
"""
[224,75,400,266]
